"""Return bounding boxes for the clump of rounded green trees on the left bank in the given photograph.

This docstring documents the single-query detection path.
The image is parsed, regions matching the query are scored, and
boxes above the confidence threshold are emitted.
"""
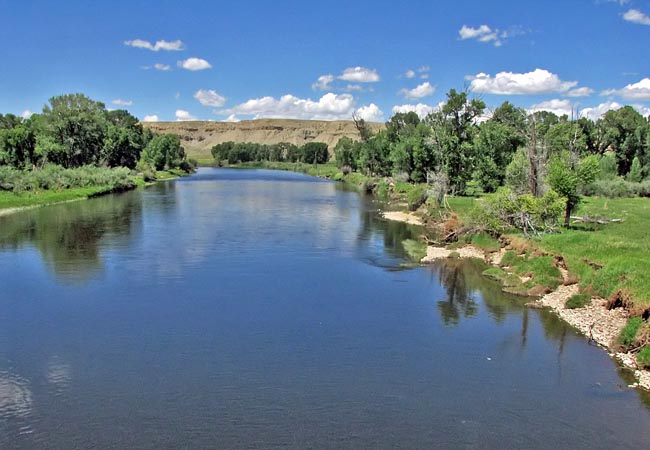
[0,94,191,174]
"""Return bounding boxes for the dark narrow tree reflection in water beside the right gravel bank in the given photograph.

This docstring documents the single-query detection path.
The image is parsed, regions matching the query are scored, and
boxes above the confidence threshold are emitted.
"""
[438,261,478,325]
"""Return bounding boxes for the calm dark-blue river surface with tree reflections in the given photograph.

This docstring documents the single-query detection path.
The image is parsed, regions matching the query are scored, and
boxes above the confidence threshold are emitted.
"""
[0,169,650,450]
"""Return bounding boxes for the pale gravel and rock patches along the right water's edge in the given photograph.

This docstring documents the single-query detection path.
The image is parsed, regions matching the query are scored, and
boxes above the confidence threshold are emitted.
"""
[382,212,650,391]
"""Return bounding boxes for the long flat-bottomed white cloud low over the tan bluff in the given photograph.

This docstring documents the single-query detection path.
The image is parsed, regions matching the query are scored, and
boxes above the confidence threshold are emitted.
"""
[215,93,364,120]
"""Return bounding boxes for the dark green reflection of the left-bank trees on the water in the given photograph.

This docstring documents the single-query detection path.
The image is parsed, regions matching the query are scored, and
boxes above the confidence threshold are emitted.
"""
[0,193,141,280]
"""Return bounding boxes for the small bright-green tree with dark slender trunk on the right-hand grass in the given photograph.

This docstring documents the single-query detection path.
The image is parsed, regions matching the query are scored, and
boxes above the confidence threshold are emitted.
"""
[547,152,600,228]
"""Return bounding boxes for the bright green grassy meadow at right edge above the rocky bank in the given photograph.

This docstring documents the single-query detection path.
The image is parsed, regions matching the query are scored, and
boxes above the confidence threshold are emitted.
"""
[539,198,650,313]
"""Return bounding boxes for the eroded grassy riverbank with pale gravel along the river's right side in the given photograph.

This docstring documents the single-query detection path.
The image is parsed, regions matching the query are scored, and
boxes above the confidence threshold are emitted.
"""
[232,162,650,390]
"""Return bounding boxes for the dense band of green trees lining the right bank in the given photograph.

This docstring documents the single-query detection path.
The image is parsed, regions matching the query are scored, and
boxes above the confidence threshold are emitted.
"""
[333,89,650,204]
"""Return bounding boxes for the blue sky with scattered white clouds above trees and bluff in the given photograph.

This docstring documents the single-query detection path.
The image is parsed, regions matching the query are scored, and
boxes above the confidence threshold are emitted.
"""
[0,0,650,120]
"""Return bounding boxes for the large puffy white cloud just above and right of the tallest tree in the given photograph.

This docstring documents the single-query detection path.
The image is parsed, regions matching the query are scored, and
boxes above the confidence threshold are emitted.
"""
[466,69,578,95]
